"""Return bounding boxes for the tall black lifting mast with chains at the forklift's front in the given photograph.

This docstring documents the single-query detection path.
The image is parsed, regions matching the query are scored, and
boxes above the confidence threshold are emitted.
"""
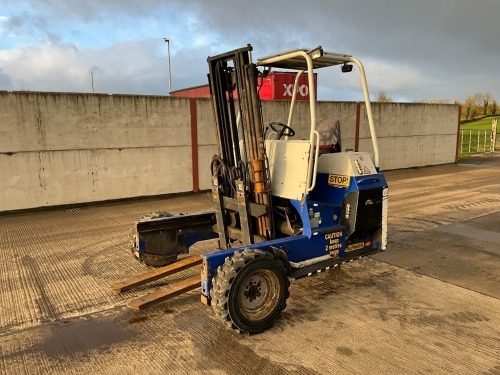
[207,45,274,248]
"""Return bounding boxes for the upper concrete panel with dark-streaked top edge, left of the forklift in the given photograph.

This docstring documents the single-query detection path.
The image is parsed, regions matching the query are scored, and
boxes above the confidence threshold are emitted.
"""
[0,92,191,152]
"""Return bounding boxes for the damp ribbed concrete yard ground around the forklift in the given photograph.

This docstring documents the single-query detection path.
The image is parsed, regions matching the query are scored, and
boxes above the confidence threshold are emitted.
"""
[0,156,500,375]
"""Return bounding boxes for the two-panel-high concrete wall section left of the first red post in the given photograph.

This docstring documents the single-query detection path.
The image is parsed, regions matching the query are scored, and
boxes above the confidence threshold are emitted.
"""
[0,92,192,211]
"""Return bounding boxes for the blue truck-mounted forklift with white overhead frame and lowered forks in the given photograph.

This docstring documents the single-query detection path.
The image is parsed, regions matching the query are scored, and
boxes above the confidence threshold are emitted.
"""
[111,45,388,334]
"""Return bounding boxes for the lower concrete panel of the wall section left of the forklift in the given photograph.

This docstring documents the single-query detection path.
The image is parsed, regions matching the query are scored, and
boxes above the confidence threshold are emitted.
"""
[0,146,192,211]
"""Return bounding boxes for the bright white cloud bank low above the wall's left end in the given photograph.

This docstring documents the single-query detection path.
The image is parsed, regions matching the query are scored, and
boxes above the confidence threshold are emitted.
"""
[0,41,167,94]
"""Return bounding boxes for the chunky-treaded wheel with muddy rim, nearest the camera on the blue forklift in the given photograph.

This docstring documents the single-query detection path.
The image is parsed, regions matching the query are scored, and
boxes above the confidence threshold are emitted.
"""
[210,250,290,334]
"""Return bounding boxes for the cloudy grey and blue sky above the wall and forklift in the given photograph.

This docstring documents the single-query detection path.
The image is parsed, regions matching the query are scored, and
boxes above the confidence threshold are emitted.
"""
[0,0,500,102]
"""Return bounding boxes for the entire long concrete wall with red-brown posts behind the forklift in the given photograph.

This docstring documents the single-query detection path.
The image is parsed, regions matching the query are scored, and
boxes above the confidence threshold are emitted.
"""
[0,91,458,211]
